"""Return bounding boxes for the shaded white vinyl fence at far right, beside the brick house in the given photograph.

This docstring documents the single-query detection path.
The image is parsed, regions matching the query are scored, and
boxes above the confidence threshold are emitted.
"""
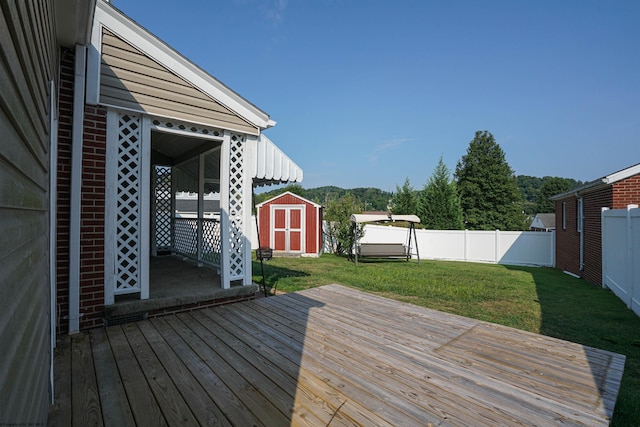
[602,205,640,316]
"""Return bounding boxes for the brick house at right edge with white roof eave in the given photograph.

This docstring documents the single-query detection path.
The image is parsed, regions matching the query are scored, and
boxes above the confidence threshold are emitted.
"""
[551,164,640,284]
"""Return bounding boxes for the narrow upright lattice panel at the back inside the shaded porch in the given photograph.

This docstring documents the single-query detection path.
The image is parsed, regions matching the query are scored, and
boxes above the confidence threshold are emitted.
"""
[153,166,172,251]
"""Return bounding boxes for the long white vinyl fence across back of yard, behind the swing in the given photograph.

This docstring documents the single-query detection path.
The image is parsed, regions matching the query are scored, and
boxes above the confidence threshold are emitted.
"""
[360,225,556,267]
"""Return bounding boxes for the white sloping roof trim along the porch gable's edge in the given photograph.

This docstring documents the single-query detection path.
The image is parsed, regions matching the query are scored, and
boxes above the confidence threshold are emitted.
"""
[94,0,275,129]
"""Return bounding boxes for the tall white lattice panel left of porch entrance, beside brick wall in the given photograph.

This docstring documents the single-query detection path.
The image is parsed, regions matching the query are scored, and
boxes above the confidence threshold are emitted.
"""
[114,113,142,294]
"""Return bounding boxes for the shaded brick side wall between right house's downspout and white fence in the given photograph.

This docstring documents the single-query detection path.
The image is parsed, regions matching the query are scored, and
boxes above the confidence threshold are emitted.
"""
[581,186,613,285]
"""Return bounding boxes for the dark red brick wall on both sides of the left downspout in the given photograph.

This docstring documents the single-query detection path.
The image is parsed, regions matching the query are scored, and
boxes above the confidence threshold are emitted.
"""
[56,49,107,332]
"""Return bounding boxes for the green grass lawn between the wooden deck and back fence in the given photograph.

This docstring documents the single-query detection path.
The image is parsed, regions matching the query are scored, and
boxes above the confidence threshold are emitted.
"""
[253,255,640,426]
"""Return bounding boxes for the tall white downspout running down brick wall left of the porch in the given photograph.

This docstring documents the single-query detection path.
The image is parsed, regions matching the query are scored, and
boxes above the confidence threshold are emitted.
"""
[69,45,87,333]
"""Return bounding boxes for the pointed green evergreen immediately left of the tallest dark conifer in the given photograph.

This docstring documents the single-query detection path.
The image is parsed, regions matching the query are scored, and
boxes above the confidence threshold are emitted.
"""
[418,157,464,230]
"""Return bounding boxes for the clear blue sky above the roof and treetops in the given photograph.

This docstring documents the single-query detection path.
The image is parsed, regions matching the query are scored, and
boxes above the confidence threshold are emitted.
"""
[112,0,640,191]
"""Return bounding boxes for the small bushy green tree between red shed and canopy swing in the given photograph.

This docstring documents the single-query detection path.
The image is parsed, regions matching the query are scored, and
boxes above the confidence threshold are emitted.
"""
[324,193,364,257]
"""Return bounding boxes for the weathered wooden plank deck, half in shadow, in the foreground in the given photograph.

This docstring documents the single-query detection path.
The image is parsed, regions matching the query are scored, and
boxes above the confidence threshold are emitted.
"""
[49,285,624,426]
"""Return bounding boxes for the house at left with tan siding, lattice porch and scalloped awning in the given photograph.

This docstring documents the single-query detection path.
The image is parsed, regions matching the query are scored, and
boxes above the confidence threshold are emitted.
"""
[0,0,302,425]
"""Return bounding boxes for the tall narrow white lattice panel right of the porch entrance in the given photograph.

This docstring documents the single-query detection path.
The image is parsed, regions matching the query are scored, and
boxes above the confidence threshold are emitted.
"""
[229,134,246,278]
